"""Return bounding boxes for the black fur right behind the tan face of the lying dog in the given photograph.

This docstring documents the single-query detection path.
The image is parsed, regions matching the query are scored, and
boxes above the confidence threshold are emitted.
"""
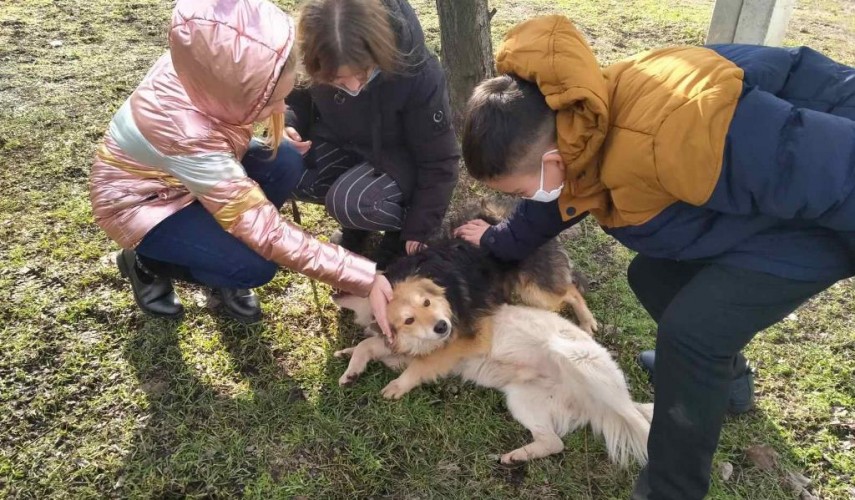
[385,239,509,337]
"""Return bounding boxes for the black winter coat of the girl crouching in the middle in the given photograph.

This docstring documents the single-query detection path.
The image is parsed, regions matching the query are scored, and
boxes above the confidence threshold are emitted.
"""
[286,0,460,242]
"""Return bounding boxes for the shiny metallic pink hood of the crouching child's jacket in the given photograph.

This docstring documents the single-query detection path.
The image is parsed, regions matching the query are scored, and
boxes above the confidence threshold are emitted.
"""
[169,0,294,125]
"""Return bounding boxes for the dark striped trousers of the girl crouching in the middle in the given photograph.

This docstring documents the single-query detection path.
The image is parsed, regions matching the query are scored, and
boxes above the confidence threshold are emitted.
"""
[294,142,404,231]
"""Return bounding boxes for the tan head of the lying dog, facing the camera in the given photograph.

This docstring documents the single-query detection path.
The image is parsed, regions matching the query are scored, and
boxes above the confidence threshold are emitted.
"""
[386,277,453,356]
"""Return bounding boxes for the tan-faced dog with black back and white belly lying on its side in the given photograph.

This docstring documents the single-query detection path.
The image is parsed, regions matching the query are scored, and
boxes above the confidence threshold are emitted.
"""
[333,218,652,465]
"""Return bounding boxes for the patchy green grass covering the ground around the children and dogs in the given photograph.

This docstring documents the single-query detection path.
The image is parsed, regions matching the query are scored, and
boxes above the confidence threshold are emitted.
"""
[0,0,855,499]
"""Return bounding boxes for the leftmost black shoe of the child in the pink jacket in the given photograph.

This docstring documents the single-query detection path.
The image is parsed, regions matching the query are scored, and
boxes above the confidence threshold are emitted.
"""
[116,250,184,319]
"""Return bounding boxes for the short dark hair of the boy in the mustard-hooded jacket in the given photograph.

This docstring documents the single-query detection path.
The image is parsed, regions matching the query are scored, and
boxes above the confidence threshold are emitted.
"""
[463,75,556,180]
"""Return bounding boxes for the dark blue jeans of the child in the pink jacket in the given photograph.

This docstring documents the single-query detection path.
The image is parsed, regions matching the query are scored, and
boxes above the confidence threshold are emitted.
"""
[136,141,303,288]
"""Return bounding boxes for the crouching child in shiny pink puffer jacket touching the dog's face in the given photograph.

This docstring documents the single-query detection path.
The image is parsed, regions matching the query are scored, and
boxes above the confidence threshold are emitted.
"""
[90,0,391,323]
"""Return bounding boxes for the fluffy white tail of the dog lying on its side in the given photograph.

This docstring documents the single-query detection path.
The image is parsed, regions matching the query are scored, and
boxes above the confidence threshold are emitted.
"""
[549,336,653,467]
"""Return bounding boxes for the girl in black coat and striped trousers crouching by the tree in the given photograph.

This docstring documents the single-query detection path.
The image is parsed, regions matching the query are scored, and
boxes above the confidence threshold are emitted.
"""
[286,0,460,265]
